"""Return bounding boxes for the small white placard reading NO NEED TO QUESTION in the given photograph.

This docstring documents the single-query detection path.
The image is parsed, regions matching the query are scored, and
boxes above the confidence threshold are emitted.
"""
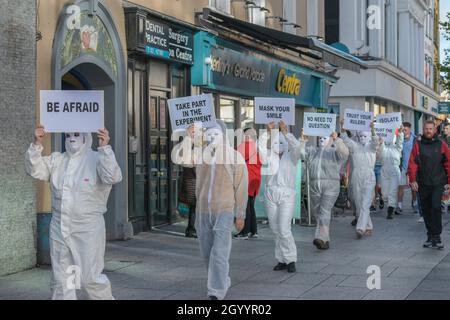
[303,112,336,137]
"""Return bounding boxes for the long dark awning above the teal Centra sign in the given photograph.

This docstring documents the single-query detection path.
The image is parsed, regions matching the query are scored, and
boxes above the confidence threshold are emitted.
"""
[202,7,367,72]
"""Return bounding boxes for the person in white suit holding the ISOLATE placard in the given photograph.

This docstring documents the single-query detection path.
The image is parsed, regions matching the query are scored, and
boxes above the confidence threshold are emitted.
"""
[380,126,403,219]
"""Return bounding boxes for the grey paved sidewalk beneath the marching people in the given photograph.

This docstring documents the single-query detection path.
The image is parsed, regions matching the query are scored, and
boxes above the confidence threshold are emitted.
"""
[0,195,450,300]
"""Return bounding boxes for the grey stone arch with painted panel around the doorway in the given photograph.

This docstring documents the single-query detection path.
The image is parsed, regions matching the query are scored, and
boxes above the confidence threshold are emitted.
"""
[52,0,132,240]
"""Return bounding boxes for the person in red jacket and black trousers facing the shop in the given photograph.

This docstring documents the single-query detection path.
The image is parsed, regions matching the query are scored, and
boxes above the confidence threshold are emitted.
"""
[236,128,262,239]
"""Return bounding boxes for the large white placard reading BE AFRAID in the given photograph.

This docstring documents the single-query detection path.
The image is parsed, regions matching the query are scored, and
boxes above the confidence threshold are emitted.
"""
[40,90,105,133]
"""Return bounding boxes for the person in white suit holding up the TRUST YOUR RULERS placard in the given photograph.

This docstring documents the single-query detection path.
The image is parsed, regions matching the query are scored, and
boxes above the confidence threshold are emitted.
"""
[341,120,379,239]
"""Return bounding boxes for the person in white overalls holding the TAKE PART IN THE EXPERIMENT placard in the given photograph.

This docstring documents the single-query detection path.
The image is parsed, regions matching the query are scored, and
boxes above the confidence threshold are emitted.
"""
[172,120,248,300]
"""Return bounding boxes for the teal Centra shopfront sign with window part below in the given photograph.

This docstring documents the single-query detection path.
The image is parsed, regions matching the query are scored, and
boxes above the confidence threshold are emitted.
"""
[192,31,337,138]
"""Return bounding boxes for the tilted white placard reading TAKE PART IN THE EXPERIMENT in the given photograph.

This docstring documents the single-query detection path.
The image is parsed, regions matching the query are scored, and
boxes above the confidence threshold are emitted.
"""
[168,94,216,130]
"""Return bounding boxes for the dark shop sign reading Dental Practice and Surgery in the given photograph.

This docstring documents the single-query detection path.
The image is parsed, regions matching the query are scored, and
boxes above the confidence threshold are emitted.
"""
[125,8,194,64]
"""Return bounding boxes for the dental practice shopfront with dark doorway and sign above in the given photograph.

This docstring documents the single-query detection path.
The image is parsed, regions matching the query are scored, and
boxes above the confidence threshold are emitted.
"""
[125,7,195,233]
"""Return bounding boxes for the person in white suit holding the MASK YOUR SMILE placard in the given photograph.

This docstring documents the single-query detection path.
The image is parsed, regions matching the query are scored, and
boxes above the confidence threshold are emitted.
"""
[258,122,300,272]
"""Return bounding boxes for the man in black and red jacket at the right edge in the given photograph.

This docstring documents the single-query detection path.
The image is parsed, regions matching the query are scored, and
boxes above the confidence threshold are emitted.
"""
[408,121,450,249]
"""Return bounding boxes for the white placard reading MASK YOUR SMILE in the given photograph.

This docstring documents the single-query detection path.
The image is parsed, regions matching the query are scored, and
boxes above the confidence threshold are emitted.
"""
[255,97,295,126]
